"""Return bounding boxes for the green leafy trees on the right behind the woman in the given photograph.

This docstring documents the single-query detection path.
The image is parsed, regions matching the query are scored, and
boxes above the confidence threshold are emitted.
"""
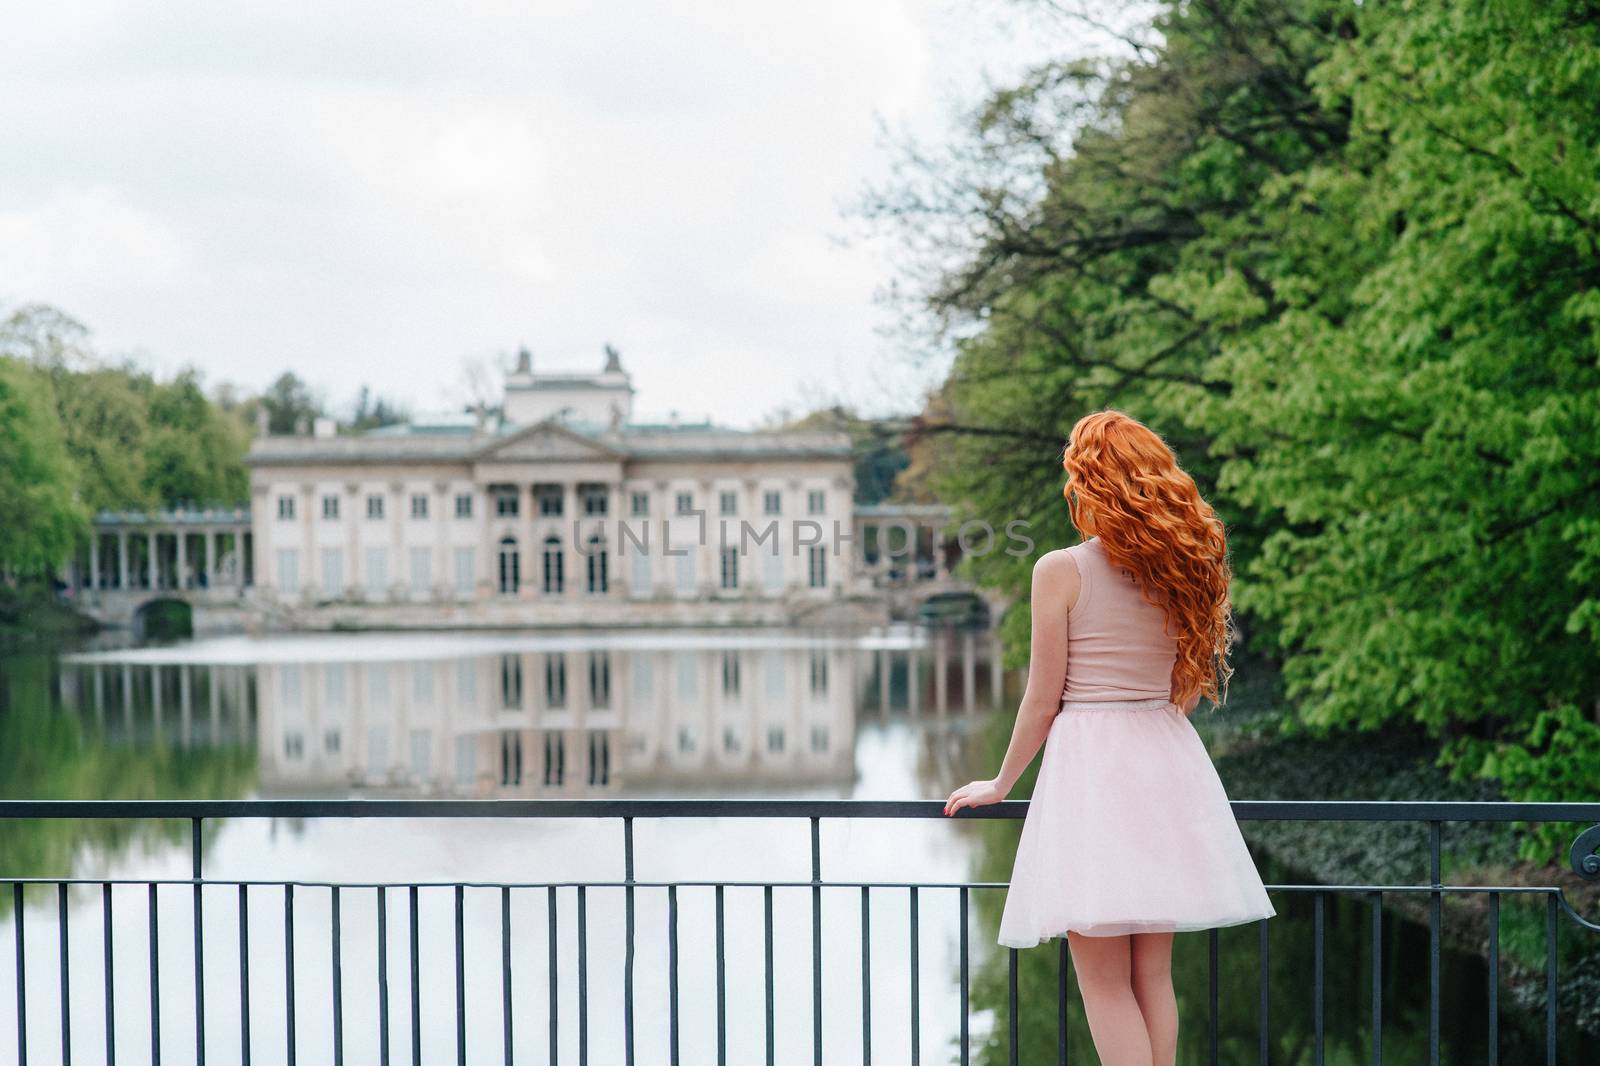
[862,0,1600,861]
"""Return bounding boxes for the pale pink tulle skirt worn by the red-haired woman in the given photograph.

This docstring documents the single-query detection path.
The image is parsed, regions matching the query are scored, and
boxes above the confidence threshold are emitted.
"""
[998,699,1277,948]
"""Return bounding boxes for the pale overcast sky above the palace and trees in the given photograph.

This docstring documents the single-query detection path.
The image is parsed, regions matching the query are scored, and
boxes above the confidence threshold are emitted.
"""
[0,0,1088,424]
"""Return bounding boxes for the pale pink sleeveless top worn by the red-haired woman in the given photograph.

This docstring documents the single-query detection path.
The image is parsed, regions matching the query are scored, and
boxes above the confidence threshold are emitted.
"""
[1062,538,1178,699]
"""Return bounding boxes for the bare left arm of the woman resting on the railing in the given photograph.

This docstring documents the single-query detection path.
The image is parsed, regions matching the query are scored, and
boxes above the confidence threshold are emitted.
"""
[944,551,1078,815]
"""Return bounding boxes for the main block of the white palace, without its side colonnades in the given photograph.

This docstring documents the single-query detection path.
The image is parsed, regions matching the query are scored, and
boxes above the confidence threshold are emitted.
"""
[246,349,877,629]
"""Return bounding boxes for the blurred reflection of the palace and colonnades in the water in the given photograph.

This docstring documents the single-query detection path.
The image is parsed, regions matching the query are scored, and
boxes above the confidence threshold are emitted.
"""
[61,632,1002,797]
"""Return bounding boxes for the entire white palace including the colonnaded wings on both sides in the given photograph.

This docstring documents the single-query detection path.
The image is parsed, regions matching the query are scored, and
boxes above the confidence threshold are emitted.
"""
[61,347,965,631]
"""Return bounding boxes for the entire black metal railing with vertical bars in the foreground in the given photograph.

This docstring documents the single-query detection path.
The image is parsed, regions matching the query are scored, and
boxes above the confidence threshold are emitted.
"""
[0,799,1600,1066]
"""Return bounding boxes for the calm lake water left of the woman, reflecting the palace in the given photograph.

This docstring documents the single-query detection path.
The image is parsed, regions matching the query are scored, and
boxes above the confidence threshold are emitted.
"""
[0,629,1005,1063]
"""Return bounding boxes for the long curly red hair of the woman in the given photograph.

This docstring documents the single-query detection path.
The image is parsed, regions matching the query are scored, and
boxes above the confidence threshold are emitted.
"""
[1061,408,1235,707]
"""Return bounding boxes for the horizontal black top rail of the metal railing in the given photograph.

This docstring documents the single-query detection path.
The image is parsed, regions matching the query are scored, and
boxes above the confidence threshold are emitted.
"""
[0,799,1600,821]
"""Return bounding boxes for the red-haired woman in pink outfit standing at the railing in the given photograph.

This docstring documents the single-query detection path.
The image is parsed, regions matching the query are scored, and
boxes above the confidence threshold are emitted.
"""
[944,410,1277,1066]
